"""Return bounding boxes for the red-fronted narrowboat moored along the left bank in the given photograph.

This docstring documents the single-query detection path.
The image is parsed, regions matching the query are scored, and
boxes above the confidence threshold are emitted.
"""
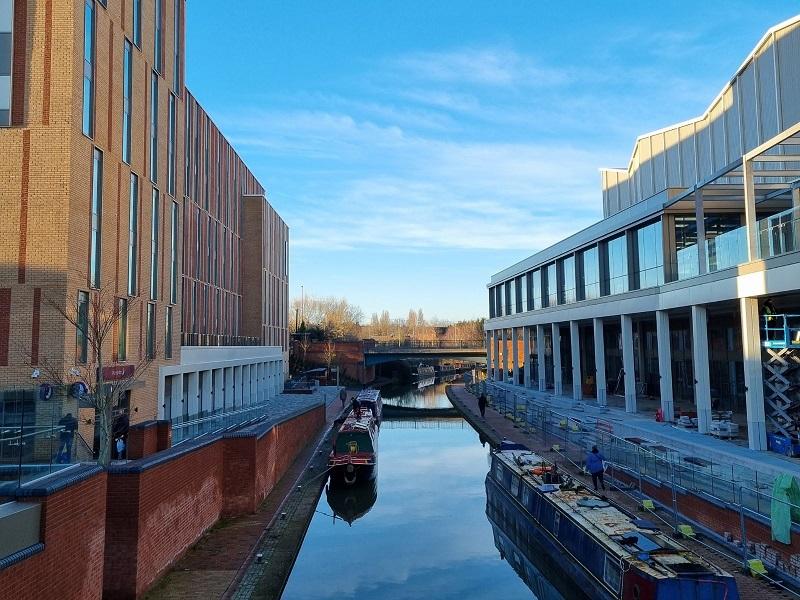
[328,390,383,485]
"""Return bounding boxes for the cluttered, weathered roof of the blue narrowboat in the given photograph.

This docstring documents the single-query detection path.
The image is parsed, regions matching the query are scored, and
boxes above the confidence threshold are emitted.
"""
[496,447,728,578]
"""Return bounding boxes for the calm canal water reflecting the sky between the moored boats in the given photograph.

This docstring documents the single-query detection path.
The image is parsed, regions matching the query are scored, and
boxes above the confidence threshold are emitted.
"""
[282,382,575,600]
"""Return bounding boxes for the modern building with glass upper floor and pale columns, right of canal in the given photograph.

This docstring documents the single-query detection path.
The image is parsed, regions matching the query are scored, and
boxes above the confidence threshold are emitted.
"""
[486,17,800,450]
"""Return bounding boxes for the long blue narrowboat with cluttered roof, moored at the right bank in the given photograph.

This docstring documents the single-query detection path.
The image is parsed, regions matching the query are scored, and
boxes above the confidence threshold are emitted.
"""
[486,443,739,600]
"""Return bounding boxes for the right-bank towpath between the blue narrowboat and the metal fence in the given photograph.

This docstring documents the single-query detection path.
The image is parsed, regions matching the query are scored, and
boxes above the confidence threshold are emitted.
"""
[447,385,795,600]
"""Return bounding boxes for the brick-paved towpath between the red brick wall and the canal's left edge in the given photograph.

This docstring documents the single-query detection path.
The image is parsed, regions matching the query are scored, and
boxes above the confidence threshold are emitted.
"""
[145,388,354,600]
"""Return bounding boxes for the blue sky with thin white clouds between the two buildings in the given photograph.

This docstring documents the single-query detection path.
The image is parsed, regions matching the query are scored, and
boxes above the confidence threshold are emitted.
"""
[187,0,799,320]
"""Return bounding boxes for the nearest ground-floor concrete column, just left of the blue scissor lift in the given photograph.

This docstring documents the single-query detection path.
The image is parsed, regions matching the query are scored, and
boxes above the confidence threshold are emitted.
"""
[739,298,767,450]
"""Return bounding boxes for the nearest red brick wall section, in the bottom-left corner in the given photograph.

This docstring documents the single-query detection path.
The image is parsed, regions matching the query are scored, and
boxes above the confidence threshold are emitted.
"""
[0,472,106,600]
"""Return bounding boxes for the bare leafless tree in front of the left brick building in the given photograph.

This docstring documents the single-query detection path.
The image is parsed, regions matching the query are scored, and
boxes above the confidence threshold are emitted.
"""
[29,288,158,466]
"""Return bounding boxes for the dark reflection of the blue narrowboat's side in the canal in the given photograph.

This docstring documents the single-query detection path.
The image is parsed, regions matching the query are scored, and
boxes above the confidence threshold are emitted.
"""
[486,477,587,600]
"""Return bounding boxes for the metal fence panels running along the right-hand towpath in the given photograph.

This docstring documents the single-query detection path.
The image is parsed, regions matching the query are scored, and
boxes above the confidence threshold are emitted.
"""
[467,381,800,580]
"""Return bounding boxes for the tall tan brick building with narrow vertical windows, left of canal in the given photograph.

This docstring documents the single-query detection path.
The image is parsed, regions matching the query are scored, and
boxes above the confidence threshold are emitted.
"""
[0,0,288,450]
